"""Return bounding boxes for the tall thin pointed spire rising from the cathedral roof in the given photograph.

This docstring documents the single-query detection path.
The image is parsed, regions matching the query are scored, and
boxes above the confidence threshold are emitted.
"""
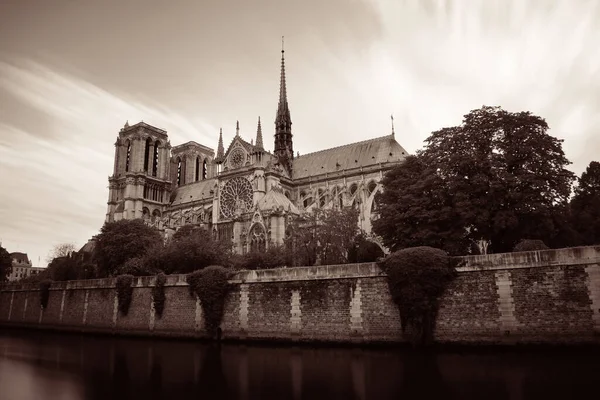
[275,41,294,173]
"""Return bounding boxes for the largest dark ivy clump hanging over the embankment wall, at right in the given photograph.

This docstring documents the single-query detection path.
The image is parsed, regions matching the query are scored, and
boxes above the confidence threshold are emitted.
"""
[380,246,456,344]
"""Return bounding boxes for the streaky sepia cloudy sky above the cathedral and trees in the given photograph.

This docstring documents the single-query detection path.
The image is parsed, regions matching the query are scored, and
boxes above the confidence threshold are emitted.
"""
[0,0,600,266]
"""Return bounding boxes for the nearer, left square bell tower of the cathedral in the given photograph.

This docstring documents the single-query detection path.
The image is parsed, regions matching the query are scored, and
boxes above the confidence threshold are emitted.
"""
[106,122,171,223]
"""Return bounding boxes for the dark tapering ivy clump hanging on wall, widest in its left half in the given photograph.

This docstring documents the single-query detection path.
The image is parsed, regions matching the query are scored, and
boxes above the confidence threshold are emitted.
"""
[186,266,231,335]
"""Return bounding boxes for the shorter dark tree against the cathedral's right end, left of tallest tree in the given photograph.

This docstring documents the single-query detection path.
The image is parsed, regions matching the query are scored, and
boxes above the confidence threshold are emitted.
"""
[373,154,469,255]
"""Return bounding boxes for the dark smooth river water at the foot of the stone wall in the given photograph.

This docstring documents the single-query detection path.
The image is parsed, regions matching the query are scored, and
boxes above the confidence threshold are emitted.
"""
[0,329,600,400]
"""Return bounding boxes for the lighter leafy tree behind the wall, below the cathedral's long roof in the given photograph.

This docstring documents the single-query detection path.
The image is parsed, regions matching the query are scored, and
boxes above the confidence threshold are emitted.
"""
[285,208,359,265]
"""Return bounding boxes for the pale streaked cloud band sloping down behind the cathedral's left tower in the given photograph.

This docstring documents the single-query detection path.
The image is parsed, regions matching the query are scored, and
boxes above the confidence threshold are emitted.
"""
[0,60,216,262]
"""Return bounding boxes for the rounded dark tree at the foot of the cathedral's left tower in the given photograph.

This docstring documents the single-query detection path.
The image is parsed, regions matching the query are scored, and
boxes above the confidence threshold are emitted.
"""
[94,219,163,277]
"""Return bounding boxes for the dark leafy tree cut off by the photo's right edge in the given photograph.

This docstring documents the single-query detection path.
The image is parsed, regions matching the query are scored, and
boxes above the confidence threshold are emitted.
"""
[571,161,600,245]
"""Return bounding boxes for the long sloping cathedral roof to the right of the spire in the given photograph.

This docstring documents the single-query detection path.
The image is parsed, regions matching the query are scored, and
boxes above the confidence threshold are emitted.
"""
[293,135,408,179]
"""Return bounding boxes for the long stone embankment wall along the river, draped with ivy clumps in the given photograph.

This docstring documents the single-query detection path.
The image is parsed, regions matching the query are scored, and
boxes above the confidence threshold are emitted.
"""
[0,247,600,343]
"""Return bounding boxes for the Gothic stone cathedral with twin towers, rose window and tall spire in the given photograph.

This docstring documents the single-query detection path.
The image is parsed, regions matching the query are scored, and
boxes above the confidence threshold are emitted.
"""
[106,50,407,253]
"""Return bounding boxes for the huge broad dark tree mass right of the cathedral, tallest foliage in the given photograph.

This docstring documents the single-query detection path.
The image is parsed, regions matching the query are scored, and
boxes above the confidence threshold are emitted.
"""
[376,106,574,254]
